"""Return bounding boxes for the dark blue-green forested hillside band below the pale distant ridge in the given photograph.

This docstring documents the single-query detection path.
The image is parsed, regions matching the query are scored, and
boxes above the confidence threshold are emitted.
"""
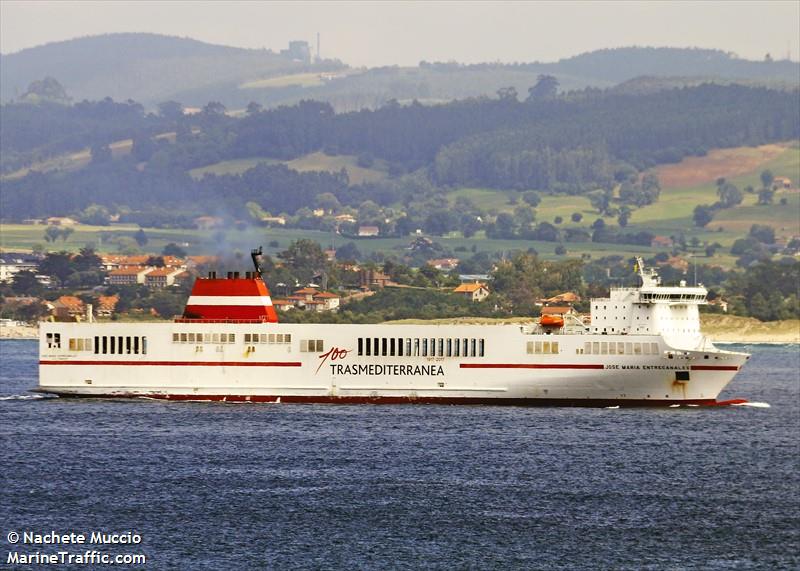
[0,85,800,219]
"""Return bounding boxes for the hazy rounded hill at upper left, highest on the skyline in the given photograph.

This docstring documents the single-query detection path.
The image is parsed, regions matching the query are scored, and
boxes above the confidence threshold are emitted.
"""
[0,33,340,104]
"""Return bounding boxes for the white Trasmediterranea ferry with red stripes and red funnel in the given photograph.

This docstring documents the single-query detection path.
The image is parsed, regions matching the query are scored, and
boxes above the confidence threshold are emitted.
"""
[37,248,750,407]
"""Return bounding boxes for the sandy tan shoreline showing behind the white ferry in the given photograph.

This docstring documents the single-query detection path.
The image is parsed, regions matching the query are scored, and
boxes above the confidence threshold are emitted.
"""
[0,314,800,345]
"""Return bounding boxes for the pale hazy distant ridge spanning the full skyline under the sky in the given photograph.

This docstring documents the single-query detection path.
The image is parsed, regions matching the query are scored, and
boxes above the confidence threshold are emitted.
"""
[0,33,800,110]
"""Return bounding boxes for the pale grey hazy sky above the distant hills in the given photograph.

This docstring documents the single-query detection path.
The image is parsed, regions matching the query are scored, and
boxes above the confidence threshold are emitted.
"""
[0,0,800,66]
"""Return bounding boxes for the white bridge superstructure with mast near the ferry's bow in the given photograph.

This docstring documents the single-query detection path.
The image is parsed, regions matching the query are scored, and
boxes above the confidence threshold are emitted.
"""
[591,258,708,349]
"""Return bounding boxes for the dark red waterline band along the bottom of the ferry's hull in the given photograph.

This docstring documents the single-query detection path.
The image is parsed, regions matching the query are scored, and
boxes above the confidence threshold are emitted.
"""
[44,391,728,407]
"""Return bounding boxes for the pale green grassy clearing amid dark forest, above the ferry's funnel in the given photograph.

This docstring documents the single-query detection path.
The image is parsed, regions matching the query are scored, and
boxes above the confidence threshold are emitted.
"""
[189,153,388,184]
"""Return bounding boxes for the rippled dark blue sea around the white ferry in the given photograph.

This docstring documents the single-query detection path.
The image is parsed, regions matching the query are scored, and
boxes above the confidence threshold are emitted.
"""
[0,340,800,570]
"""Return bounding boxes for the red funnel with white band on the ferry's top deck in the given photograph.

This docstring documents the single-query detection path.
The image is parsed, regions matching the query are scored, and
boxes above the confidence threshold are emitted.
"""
[183,273,278,323]
